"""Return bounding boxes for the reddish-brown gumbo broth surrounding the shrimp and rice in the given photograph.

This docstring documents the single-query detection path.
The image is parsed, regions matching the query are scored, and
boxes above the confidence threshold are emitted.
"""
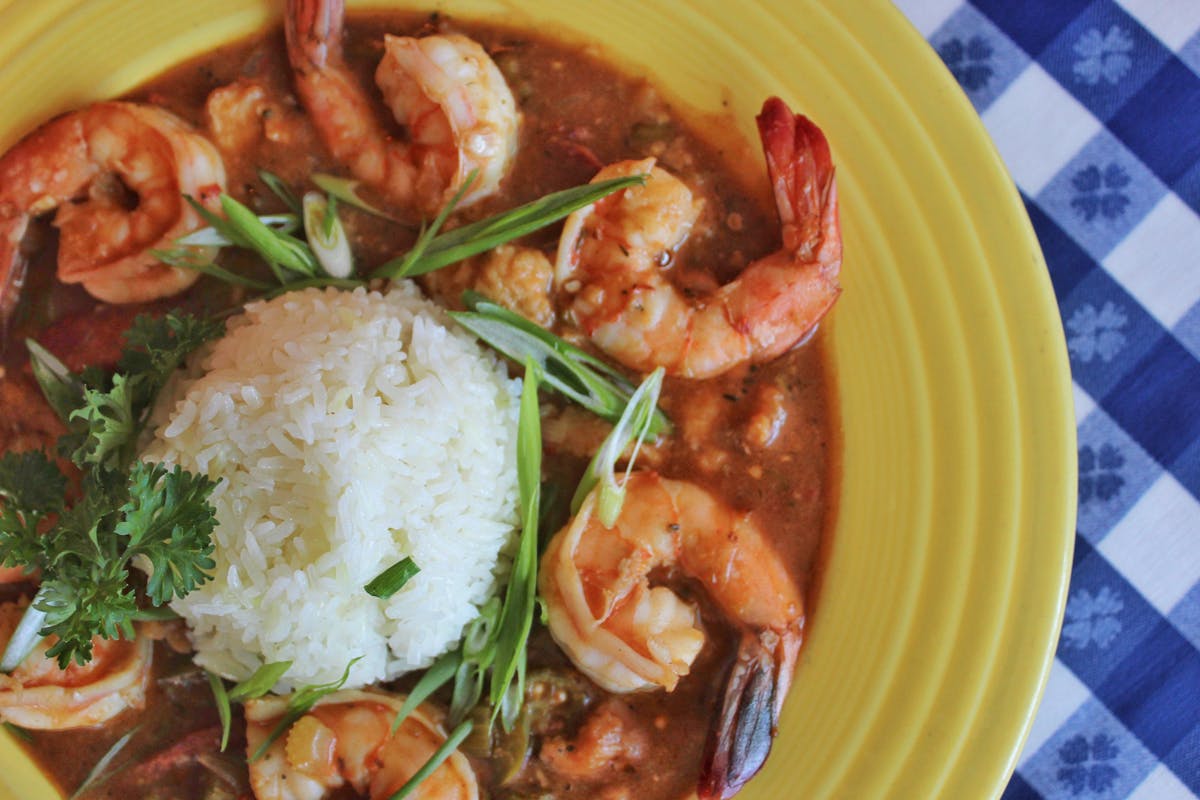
[0,7,836,800]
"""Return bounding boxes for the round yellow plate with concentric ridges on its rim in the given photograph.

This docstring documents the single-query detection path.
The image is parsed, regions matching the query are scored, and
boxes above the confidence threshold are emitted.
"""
[0,0,1075,800]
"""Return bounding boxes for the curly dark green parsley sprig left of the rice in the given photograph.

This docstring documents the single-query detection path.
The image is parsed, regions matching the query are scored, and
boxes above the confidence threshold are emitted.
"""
[0,313,222,670]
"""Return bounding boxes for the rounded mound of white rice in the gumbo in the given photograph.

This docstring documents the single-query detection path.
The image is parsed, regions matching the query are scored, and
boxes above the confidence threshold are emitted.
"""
[143,283,520,691]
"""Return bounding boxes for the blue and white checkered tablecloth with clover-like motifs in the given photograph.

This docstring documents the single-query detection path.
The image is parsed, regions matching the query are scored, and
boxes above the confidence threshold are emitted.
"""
[896,0,1200,800]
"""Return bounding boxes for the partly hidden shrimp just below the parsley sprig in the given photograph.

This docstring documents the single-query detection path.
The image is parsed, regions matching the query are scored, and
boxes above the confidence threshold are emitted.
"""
[0,603,152,730]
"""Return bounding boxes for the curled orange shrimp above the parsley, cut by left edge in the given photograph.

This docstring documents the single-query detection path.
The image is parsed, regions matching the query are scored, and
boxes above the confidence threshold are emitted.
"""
[0,102,224,325]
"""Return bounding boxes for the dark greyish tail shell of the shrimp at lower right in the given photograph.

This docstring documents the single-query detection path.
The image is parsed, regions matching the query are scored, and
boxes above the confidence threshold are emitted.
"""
[696,631,800,800]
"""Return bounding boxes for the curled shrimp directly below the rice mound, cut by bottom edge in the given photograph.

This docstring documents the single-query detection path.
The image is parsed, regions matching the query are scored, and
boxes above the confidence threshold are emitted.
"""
[246,690,479,800]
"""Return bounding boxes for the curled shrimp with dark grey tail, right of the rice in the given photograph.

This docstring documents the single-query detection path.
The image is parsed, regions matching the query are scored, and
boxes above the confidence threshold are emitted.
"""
[539,470,804,800]
